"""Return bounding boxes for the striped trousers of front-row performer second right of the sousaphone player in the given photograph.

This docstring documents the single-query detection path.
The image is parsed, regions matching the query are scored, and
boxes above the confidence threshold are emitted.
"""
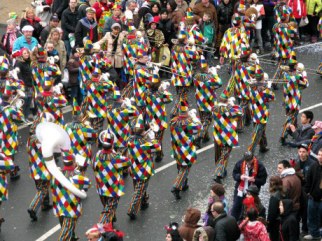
[127,179,149,215]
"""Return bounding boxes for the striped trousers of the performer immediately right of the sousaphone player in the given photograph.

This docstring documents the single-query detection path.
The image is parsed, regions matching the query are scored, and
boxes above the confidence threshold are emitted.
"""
[98,196,120,224]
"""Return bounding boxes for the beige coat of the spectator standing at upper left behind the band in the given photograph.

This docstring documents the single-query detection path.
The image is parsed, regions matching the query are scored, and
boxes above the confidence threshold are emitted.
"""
[94,32,126,68]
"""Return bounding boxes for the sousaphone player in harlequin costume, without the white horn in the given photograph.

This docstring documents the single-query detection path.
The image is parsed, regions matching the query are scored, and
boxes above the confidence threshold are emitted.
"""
[51,152,91,241]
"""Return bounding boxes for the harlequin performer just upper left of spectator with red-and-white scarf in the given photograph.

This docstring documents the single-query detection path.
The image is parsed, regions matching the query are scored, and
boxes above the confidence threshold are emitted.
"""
[212,90,243,183]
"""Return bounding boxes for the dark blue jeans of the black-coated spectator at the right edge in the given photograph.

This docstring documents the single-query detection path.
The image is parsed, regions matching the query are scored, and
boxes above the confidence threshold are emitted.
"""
[307,197,322,237]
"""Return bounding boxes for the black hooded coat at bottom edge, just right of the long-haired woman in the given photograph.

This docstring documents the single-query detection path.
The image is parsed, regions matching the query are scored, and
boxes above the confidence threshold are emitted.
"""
[281,199,299,241]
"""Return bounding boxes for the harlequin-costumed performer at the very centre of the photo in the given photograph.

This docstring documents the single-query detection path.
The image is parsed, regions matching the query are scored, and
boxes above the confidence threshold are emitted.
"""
[146,72,173,162]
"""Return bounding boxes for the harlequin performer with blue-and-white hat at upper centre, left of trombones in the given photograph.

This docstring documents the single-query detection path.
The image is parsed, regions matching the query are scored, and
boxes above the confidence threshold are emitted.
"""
[171,26,199,117]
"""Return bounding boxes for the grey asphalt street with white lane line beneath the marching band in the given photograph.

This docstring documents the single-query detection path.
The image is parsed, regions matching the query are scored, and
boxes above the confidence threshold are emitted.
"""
[0,44,322,241]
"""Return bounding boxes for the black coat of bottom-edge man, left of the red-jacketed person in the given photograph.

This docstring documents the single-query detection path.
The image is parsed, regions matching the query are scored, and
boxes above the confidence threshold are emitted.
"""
[210,212,240,241]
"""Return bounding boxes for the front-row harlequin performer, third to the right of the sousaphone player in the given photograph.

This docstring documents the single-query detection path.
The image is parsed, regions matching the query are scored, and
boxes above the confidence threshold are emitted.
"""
[170,99,202,199]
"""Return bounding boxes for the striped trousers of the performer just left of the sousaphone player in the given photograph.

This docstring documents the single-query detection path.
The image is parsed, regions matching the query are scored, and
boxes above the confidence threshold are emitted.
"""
[29,180,50,213]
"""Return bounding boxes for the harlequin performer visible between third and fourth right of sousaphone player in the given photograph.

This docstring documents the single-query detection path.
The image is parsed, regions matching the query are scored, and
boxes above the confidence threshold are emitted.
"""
[194,55,222,148]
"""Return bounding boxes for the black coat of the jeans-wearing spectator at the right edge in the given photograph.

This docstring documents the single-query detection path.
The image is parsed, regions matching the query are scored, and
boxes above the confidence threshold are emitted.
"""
[305,162,322,202]
